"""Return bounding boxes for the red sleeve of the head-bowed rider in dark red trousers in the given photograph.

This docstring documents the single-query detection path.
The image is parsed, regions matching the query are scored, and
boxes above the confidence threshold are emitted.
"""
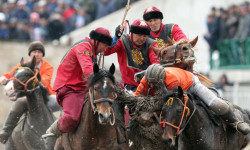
[75,44,93,80]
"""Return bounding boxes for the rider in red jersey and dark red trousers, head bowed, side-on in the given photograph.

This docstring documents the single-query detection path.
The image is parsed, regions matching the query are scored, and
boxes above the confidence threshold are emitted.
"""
[43,27,112,150]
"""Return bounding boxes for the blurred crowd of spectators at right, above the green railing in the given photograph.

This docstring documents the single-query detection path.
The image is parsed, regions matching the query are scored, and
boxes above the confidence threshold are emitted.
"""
[204,2,250,53]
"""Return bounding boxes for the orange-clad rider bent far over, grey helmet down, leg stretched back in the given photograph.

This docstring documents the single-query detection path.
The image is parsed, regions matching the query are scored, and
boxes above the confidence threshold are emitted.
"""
[134,64,250,135]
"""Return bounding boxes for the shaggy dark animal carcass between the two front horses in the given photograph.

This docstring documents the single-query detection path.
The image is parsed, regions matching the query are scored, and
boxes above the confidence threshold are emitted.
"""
[115,85,174,150]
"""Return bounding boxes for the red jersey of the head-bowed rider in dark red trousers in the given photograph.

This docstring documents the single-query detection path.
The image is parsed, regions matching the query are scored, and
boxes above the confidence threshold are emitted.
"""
[53,37,96,91]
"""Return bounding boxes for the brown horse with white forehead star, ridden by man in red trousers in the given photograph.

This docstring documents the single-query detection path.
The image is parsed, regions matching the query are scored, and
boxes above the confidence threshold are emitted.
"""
[55,64,129,150]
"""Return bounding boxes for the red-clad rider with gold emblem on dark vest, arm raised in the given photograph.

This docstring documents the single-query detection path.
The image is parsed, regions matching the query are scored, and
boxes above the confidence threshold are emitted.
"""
[104,19,158,91]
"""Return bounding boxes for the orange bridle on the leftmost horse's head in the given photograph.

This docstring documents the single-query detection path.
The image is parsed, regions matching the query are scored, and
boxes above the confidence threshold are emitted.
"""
[12,67,39,92]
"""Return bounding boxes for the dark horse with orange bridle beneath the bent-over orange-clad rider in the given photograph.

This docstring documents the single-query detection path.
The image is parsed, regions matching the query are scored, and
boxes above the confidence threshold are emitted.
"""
[160,87,249,150]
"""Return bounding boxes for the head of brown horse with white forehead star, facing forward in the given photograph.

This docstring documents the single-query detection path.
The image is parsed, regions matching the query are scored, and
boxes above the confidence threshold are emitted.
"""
[89,64,116,125]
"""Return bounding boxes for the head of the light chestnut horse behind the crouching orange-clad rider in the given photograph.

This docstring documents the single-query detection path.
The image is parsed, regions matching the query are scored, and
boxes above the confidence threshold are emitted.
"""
[159,36,198,70]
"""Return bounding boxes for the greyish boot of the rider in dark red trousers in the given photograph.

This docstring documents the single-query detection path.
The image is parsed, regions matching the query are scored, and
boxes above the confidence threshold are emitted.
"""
[42,120,62,150]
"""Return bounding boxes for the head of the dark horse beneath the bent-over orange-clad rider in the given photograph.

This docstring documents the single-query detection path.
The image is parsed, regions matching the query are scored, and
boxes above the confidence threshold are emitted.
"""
[160,87,190,147]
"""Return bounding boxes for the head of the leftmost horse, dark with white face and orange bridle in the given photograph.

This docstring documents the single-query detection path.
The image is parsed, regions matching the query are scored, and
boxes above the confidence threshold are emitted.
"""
[8,57,41,100]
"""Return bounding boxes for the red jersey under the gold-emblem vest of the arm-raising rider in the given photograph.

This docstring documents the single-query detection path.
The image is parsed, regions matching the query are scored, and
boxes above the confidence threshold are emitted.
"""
[104,33,158,86]
